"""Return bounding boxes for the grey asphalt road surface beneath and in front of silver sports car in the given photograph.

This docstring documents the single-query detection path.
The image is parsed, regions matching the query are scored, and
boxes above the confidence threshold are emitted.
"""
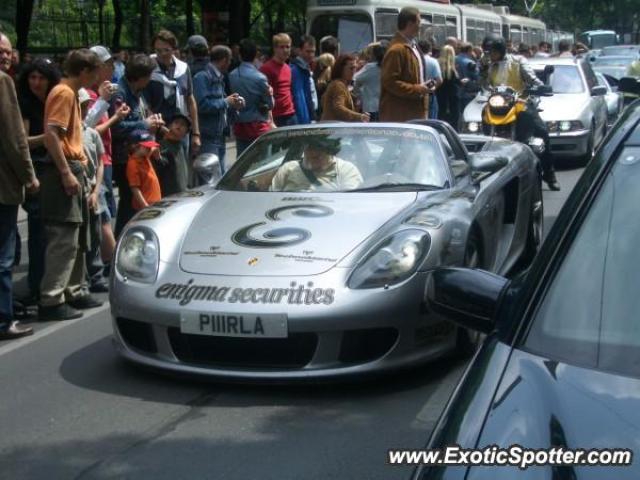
[0,154,581,480]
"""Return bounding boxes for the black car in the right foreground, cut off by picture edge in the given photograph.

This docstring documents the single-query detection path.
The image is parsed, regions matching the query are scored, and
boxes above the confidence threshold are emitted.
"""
[413,92,640,480]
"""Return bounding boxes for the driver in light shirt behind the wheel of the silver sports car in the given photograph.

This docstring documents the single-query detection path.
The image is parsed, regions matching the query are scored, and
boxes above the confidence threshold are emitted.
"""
[271,136,362,192]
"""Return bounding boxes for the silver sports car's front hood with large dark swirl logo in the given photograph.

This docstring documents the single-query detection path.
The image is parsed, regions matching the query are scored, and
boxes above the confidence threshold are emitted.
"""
[180,191,417,276]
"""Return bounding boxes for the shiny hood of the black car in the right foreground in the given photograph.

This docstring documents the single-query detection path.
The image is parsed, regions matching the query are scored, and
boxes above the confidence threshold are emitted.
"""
[467,350,640,480]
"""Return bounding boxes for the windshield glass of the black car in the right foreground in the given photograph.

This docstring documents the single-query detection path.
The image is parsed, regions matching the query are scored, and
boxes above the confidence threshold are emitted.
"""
[524,147,640,377]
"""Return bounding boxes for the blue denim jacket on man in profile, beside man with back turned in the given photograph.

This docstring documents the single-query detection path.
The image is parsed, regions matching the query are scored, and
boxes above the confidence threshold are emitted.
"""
[193,63,229,140]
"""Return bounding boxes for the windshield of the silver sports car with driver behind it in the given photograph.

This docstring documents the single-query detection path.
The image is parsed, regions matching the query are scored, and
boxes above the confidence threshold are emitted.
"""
[218,127,448,192]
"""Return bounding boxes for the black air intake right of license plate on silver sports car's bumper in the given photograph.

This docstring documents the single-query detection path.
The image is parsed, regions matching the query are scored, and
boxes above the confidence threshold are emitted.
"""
[339,328,398,364]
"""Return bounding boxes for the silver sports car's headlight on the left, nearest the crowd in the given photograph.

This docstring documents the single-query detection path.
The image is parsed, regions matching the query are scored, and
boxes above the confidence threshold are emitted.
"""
[116,227,160,283]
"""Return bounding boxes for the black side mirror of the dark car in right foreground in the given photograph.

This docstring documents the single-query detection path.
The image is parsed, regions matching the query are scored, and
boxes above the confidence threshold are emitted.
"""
[427,268,509,334]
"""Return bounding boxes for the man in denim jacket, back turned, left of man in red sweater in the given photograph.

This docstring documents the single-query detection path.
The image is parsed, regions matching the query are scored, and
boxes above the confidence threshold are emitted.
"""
[229,38,273,155]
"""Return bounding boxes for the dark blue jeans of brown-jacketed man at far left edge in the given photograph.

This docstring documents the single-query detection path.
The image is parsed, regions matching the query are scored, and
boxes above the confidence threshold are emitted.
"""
[0,203,18,329]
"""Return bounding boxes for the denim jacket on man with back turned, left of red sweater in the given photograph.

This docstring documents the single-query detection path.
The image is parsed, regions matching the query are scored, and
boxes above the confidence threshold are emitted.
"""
[229,62,273,123]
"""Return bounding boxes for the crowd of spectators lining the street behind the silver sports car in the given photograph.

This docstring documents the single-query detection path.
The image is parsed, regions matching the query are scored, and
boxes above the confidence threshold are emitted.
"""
[0,8,584,338]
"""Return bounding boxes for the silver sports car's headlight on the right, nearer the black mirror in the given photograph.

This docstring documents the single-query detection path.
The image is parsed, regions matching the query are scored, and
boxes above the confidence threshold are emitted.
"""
[347,229,431,289]
